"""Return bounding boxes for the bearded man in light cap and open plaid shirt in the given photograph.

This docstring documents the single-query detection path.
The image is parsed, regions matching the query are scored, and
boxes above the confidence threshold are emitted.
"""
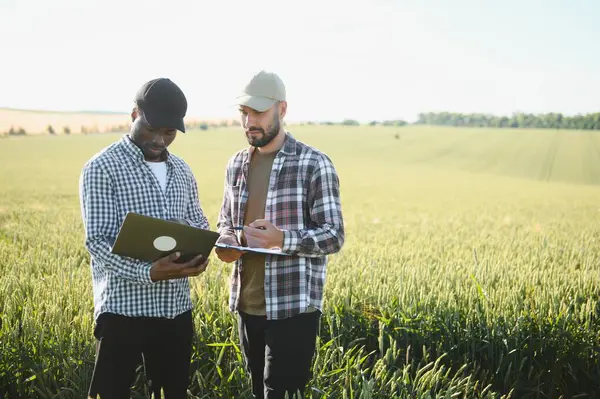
[216,71,344,399]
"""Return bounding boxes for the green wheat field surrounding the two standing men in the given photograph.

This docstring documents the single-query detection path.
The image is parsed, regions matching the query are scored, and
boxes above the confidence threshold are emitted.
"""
[0,126,600,398]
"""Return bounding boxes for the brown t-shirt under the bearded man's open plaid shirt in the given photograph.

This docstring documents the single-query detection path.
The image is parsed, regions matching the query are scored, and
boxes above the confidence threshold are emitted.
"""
[239,151,277,316]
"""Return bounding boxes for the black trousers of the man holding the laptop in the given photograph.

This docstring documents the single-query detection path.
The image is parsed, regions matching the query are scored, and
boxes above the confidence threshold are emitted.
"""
[89,311,194,399]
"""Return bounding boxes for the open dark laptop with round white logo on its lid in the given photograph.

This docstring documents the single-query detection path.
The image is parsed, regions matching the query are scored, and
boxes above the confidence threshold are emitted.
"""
[111,212,219,263]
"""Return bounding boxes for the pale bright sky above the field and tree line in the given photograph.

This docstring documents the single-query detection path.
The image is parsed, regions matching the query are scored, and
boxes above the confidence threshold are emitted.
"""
[0,0,600,122]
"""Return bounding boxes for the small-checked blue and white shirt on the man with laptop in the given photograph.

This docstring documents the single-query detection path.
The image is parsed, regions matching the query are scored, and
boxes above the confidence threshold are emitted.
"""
[79,135,209,318]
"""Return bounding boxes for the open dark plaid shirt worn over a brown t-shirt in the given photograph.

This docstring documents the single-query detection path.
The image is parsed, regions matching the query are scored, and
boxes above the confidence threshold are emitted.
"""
[217,133,344,320]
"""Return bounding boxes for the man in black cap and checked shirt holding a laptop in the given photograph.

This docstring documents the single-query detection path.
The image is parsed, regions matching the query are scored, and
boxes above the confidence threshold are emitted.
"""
[80,78,209,399]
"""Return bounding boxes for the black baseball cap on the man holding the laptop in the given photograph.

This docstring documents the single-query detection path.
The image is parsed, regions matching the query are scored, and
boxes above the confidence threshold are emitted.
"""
[135,78,187,133]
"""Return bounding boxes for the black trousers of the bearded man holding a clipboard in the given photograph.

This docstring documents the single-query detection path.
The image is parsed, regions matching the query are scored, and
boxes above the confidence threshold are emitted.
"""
[238,311,321,399]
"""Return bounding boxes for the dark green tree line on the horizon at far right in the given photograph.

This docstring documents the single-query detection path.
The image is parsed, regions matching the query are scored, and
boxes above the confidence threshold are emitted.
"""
[415,112,600,130]
